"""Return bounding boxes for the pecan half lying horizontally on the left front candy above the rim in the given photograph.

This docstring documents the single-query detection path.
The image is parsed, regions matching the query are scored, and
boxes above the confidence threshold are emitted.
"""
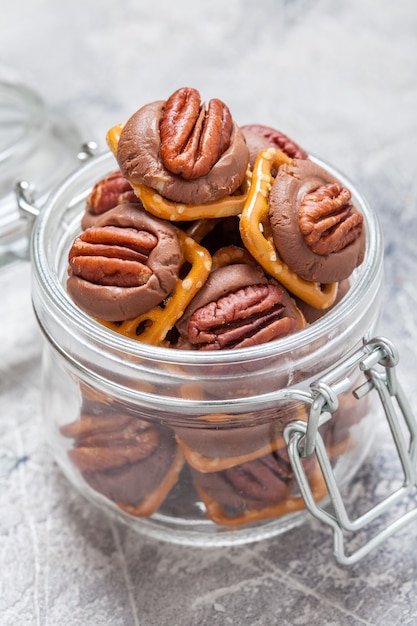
[69,225,158,287]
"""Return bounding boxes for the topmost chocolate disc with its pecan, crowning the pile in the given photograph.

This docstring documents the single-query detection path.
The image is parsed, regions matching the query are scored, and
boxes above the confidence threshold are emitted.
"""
[108,87,249,210]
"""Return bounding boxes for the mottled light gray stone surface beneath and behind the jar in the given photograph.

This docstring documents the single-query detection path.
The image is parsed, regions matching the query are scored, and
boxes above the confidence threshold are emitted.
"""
[0,0,417,626]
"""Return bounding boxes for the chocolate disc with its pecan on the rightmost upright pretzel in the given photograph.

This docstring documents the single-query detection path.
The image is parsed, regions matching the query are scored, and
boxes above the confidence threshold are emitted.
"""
[269,159,365,282]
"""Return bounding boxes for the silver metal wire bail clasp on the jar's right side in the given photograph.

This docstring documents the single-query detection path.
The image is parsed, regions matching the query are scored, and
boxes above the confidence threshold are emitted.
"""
[284,337,417,565]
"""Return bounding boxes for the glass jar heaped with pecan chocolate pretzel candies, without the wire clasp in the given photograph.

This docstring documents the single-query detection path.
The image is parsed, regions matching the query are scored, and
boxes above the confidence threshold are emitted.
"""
[32,88,382,545]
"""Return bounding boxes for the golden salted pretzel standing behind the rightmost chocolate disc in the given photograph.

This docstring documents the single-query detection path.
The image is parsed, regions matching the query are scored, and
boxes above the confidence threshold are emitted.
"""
[240,148,337,309]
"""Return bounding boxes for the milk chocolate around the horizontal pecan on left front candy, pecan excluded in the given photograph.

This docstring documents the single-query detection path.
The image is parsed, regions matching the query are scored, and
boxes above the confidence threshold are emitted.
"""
[67,204,181,322]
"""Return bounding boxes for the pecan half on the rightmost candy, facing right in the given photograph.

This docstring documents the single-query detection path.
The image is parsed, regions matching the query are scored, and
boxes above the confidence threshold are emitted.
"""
[299,183,363,256]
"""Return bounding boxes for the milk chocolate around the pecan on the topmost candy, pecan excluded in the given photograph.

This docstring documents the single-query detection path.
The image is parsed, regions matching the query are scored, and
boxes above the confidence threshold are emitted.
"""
[117,100,249,204]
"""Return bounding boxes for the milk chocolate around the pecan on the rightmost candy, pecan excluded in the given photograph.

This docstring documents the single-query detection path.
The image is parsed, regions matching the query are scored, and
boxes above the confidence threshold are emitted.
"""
[269,159,365,283]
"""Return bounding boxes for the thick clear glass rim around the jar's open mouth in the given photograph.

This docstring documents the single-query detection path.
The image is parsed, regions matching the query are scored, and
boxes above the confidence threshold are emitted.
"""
[31,152,383,366]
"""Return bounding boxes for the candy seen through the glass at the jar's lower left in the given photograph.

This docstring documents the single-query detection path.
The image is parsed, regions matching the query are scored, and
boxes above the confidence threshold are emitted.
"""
[61,394,184,517]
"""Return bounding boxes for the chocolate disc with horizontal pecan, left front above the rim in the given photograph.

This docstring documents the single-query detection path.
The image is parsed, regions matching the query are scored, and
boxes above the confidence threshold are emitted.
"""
[67,204,181,321]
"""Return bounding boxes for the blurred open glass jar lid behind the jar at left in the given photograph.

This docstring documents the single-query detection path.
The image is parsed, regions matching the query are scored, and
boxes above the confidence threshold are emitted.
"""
[0,80,90,269]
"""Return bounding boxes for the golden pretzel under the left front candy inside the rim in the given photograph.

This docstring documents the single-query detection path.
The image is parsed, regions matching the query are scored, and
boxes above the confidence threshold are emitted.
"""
[100,229,211,346]
